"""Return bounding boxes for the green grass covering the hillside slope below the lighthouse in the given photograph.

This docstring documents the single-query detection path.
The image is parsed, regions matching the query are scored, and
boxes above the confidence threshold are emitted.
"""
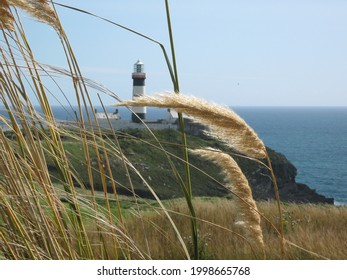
[40,130,258,199]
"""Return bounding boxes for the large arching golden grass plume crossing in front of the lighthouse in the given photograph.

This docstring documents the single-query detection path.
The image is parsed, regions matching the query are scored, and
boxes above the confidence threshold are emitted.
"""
[115,94,266,158]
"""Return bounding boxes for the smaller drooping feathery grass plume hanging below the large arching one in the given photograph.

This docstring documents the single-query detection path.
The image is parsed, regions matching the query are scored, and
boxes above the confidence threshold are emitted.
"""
[191,148,264,248]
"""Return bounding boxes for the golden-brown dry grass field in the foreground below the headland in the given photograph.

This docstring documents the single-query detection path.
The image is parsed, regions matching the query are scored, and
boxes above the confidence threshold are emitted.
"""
[123,199,347,259]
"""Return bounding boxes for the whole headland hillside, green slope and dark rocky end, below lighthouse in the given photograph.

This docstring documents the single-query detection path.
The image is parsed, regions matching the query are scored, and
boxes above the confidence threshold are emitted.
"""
[49,130,333,203]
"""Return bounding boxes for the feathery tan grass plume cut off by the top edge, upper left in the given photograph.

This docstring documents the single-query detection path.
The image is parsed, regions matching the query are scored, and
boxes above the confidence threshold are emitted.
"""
[8,0,60,29]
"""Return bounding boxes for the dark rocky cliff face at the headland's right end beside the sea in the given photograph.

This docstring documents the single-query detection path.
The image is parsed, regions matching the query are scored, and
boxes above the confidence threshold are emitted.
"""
[248,150,334,204]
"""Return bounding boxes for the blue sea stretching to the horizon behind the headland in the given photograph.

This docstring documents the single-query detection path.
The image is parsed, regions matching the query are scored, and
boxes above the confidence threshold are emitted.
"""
[0,107,347,205]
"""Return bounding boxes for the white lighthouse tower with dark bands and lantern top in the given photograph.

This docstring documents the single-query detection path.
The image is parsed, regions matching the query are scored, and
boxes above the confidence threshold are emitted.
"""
[131,60,147,123]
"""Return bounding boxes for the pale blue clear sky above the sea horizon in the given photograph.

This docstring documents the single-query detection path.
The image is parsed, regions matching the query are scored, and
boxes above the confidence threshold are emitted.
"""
[17,0,347,106]
